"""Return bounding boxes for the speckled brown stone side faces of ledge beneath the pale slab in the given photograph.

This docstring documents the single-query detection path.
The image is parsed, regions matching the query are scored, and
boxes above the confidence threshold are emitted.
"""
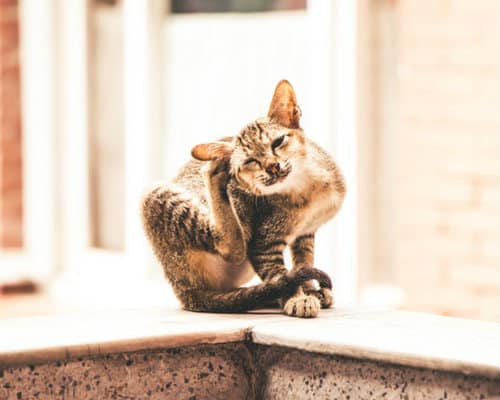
[0,342,500,400]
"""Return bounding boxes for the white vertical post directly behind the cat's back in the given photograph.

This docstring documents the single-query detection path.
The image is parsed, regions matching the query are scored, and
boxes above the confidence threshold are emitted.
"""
[123,0,166,270]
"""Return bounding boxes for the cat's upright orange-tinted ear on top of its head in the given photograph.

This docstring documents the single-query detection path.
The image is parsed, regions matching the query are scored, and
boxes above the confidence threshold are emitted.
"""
[267,80,301,128]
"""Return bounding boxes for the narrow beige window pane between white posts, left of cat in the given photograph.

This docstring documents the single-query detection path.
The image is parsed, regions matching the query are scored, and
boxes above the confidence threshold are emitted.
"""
[88,0,125,250]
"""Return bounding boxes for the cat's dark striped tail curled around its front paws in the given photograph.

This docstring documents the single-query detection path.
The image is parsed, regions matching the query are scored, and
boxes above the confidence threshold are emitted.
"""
[183,268,332,313]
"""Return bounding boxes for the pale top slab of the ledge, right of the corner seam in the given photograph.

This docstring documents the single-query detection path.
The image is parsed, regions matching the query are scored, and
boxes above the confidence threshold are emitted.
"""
[252,310,500,378]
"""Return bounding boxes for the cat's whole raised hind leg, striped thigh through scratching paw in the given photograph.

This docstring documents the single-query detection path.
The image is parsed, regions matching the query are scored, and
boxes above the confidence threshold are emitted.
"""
[142,162,254,310]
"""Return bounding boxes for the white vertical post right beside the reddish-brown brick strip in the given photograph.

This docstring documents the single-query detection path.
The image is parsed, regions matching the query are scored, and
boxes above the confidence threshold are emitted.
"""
[19,0,57,281]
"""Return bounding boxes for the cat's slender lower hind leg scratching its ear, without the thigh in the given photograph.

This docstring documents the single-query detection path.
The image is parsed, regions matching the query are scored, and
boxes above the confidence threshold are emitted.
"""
[204,160,247,264]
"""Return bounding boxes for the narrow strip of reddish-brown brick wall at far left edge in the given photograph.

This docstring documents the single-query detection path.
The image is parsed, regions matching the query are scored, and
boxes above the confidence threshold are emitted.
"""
[0,0,22,248]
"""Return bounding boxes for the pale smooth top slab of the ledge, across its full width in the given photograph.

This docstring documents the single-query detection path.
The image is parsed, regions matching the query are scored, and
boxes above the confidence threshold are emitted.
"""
[0,308,500,378]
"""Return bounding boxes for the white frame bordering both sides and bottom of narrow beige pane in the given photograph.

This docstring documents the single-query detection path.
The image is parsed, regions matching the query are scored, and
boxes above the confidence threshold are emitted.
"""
[58,0,164,286]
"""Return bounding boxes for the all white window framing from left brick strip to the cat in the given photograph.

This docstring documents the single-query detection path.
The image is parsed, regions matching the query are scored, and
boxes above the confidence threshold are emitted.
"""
[8,0,165,290]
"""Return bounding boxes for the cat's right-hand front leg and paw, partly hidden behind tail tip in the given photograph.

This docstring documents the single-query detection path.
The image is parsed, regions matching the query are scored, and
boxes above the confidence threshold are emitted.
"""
[290,233,334,308]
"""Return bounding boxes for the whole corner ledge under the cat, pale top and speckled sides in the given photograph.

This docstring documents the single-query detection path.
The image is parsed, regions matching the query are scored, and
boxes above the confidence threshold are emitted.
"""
[0,308,500,400]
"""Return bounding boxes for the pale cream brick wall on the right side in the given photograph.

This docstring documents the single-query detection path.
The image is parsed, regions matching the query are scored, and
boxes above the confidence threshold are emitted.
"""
[378,0,500,319]
